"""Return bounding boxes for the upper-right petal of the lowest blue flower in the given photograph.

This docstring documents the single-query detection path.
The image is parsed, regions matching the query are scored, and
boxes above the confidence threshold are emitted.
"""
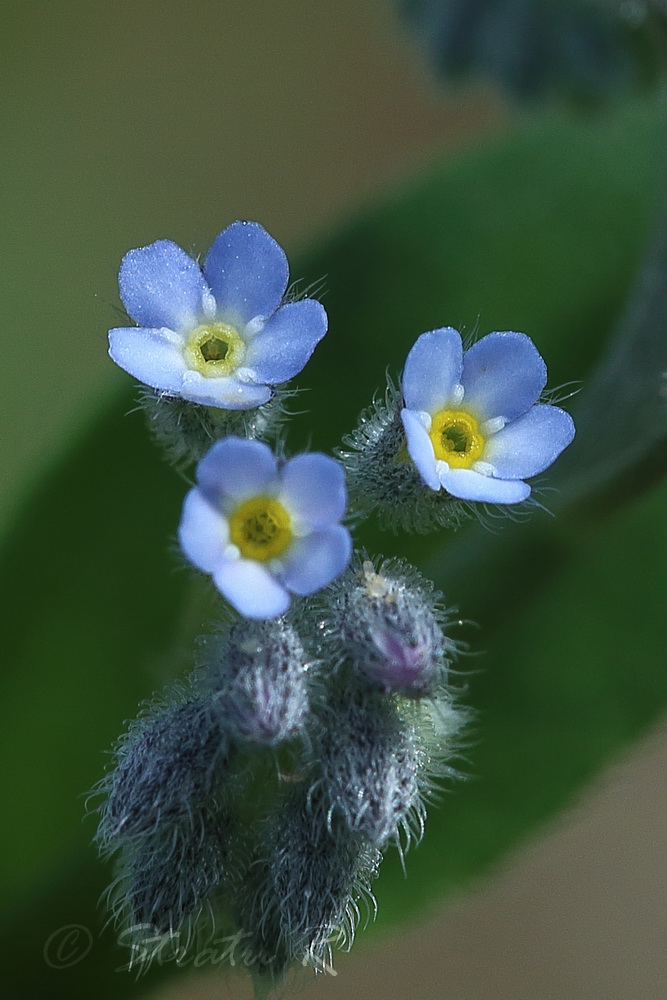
[280,452,347,528]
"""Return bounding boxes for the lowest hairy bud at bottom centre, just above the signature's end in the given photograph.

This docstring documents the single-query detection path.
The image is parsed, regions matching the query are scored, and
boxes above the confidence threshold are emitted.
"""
[241,786,381,978]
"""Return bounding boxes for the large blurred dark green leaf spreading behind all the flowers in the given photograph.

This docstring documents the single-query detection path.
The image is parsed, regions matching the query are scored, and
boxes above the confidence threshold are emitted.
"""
[0,99,664,1000]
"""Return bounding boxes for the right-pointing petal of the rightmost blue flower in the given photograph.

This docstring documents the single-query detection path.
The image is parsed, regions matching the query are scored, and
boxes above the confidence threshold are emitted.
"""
[483,406,574,479]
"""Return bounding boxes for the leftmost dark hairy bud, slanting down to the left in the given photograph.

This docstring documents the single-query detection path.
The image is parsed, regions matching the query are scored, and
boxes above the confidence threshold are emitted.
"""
[97,698,228,851]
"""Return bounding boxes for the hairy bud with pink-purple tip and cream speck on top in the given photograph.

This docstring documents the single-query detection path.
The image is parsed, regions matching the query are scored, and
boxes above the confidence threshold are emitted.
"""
[325,560,456,698]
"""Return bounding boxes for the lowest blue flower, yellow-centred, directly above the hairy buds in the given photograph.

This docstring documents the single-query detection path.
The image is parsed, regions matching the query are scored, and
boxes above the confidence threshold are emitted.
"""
[179,437,352,618]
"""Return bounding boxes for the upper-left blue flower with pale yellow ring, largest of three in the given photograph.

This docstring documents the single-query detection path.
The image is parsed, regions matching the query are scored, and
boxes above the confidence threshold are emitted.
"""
[109,222,327,410]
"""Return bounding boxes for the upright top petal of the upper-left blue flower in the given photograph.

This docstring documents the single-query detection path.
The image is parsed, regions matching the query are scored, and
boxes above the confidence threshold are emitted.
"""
[204,222,289,326]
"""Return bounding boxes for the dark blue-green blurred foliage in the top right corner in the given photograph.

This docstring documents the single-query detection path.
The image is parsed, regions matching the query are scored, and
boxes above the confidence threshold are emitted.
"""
[402,0,667,103]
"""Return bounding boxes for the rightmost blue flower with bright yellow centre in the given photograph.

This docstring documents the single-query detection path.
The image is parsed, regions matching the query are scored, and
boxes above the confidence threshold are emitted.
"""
[401,327,574,504]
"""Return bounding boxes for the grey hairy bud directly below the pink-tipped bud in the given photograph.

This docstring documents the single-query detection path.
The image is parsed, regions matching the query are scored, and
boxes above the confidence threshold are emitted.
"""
[313,683,427,847]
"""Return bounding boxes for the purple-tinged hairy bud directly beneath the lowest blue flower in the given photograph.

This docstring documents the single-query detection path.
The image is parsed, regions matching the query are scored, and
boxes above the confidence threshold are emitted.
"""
[200,619,312,747]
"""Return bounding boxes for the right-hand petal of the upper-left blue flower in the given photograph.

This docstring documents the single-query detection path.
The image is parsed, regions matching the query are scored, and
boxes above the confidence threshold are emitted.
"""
[244,299,327,385]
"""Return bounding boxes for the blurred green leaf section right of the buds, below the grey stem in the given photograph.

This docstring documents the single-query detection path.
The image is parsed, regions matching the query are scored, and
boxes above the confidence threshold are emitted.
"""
[378,472,667,921]
